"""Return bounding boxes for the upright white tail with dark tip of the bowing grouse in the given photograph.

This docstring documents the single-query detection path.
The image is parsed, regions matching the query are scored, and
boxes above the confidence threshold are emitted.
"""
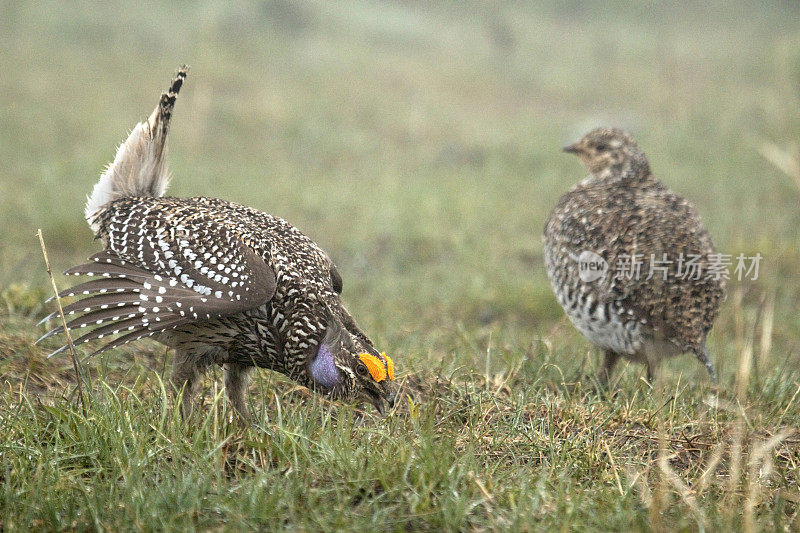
[85,65,189,233]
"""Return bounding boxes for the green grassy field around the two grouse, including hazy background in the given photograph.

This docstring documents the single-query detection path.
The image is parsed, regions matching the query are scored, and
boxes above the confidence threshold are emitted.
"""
[0,0,800,531]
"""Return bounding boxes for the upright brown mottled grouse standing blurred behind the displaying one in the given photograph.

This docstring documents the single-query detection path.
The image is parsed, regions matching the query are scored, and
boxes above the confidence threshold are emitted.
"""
[544,128,725,382]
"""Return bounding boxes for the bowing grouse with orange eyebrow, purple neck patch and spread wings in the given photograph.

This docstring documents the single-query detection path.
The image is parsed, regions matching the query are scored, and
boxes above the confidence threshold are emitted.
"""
[42,68,394,416]
